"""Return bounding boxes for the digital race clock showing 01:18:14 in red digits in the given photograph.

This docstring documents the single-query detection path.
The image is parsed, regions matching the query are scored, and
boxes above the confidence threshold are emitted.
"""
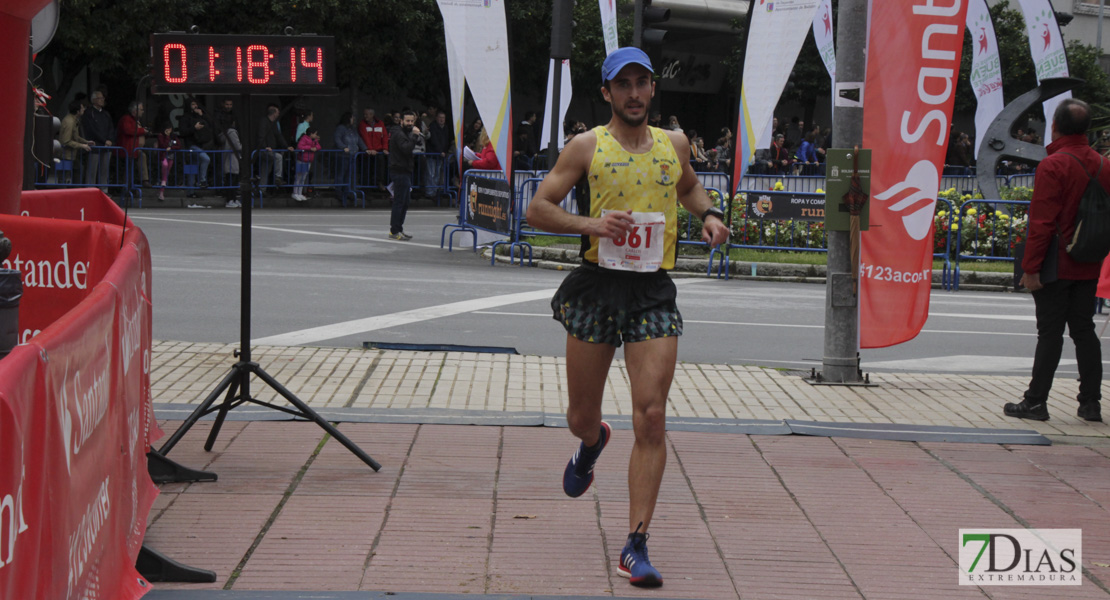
[150,33,337,94]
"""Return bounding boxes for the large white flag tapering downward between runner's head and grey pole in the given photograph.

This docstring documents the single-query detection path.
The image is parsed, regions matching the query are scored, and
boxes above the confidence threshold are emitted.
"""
[733,0,819,184]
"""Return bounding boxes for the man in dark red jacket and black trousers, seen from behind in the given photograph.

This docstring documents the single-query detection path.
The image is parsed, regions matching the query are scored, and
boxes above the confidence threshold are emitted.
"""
[1002,99,1110,421]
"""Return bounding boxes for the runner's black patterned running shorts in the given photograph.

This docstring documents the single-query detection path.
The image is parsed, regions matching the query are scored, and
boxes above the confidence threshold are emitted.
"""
[552,263,683,347]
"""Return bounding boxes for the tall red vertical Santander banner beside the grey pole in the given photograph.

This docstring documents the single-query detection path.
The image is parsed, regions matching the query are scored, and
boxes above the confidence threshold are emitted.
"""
[859,0,968,348]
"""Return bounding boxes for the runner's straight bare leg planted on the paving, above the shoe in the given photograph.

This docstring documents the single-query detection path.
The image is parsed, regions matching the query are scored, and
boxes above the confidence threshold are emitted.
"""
[626,336,678,532]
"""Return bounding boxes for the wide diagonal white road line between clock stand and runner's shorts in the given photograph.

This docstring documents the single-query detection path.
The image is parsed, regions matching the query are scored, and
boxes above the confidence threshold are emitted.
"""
[251,289,555,346]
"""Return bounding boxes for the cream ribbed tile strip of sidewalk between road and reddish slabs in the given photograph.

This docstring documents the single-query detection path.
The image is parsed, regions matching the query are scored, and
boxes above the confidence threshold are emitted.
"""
[151,342,1110,437]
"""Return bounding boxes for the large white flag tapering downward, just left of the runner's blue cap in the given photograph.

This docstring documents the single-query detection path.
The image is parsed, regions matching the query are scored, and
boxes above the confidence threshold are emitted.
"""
[436,0,513,177]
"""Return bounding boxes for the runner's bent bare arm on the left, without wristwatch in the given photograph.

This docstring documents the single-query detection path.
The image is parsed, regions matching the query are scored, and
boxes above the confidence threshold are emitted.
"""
[526,132,633,238]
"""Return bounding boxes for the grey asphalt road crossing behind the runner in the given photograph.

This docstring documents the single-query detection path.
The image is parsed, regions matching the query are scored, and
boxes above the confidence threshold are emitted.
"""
[131,206,1104,376]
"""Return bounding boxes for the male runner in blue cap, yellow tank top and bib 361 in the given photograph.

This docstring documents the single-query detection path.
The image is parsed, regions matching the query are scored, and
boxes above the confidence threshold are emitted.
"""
[527,48,728,587]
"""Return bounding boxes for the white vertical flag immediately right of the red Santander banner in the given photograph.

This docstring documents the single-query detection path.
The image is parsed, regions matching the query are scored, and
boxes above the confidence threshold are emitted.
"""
[968,0,1006,159]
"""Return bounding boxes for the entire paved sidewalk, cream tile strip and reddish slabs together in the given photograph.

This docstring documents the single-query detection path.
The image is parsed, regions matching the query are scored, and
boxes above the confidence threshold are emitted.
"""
[147,342,1110,600]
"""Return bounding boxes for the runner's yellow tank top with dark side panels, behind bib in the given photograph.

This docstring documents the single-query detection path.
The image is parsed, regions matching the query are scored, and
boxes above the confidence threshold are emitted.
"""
[578,125,683,270]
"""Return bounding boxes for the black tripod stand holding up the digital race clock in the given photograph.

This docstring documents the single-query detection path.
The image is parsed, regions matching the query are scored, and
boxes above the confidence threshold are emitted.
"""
[159,94,382,471]
